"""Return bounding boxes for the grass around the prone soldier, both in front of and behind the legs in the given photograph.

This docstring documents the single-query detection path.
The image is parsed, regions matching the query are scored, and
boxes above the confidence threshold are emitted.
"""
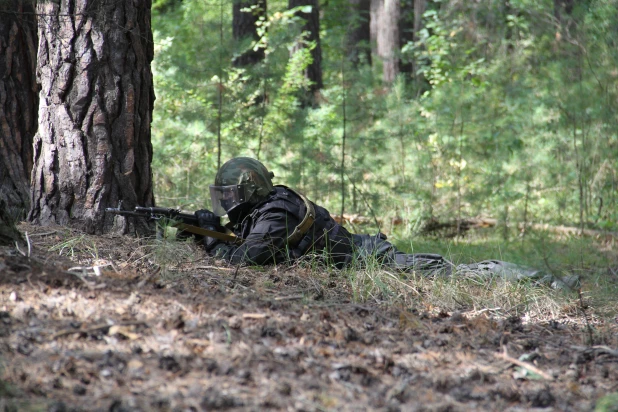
[31,222,618,320]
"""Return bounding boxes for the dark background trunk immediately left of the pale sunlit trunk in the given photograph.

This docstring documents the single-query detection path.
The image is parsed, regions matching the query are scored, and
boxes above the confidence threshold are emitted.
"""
[346,0,371,66]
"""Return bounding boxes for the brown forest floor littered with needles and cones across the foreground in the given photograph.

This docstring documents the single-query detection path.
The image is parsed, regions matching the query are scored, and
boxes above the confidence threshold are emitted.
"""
[0,225,618,411]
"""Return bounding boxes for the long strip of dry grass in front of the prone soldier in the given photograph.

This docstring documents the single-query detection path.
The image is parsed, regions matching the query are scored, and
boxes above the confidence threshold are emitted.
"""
[20,224,617,321]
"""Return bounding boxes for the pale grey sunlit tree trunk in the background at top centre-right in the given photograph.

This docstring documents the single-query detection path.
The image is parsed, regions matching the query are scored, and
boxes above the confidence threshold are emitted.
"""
[371,0,400,83]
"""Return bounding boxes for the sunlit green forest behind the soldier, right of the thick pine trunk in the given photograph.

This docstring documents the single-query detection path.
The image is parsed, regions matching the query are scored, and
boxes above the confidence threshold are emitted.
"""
[152,0,618,245]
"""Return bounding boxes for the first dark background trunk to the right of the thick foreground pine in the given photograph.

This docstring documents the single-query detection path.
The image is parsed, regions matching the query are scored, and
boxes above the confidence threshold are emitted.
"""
[232,0,266,67]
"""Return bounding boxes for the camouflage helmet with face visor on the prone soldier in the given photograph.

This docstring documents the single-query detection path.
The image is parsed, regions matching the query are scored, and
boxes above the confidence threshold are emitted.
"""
[210,157,274,216]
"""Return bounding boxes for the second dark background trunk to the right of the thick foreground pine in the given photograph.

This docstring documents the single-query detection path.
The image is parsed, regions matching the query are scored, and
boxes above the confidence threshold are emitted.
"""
[288,0,324,95]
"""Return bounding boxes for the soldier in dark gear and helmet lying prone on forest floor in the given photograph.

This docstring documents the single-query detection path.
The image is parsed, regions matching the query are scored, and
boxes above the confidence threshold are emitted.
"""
[195,157,564,287]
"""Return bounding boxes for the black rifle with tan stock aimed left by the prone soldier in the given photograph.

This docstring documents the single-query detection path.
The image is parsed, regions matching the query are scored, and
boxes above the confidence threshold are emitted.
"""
[105,206,243,245]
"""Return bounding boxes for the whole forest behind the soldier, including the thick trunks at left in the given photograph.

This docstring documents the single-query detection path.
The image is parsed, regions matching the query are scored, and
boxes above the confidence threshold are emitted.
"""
[0,0,618,262]
